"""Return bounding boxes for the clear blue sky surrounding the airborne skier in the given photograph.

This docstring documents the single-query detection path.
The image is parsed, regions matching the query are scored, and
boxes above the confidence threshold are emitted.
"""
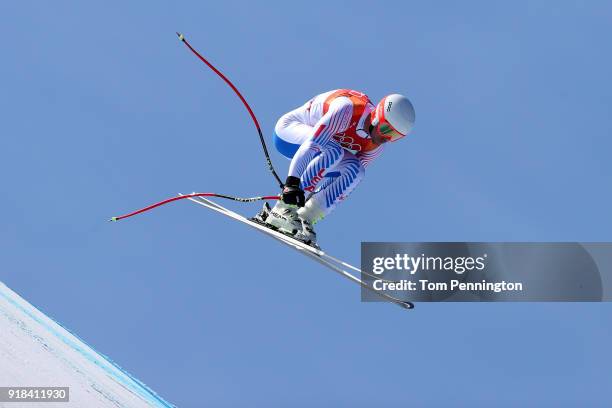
[0,1,612,407]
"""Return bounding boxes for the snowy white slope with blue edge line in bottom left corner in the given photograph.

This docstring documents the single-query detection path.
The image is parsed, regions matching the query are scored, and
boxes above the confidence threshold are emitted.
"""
[0,282,173,408]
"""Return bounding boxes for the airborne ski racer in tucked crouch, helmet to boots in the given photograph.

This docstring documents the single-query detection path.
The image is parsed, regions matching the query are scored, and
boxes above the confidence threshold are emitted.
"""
[256,89,415,245]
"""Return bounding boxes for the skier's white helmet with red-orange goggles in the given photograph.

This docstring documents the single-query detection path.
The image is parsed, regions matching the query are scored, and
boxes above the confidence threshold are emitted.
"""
[372,94,415,142]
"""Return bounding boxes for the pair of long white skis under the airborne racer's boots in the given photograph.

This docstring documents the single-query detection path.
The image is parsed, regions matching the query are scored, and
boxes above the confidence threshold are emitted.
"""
[179,193,414,309]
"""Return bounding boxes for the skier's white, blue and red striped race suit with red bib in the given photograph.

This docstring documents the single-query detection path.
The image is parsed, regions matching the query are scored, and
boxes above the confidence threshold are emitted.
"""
[274,89,383,222]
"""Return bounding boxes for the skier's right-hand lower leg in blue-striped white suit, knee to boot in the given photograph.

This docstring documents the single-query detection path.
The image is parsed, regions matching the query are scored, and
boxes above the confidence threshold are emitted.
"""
[298,151,365,224]
